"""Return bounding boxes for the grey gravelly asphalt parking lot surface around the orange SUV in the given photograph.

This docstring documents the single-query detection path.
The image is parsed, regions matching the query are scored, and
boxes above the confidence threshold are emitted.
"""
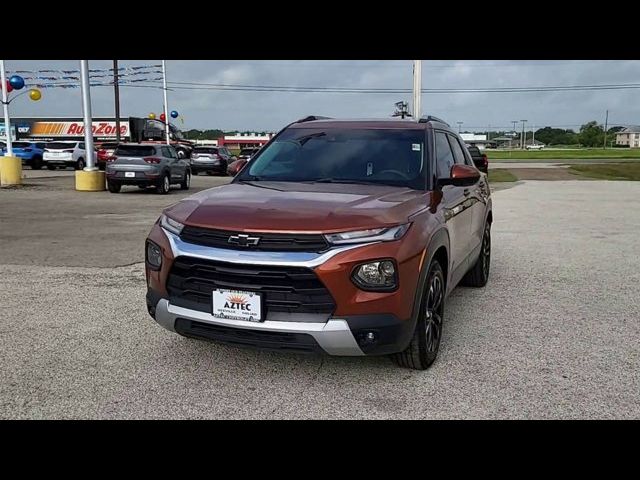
[0,171,640,419]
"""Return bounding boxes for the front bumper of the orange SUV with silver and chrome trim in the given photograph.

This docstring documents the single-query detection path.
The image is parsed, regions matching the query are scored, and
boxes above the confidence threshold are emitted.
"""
[146,225,420,356]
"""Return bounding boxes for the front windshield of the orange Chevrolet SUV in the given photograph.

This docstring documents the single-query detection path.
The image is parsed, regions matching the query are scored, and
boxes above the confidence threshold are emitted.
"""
[238,128,425,189]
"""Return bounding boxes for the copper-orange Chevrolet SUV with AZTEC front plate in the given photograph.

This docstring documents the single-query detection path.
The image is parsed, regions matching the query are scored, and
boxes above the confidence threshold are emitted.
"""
[145,116,492,369]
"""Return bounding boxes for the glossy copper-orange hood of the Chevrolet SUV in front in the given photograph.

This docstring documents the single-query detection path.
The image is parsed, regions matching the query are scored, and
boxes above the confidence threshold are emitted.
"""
[165,182,429,233]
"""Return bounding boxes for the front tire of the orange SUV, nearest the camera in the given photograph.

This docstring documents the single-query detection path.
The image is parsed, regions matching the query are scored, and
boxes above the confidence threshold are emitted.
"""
[392,260,445,370]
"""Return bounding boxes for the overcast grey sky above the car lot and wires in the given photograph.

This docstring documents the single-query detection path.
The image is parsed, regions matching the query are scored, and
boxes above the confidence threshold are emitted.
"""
[5,60,640,131]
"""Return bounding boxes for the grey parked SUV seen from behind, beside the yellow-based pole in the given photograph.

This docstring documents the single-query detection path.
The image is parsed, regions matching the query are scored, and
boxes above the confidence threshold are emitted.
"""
[106,143,191,194]
